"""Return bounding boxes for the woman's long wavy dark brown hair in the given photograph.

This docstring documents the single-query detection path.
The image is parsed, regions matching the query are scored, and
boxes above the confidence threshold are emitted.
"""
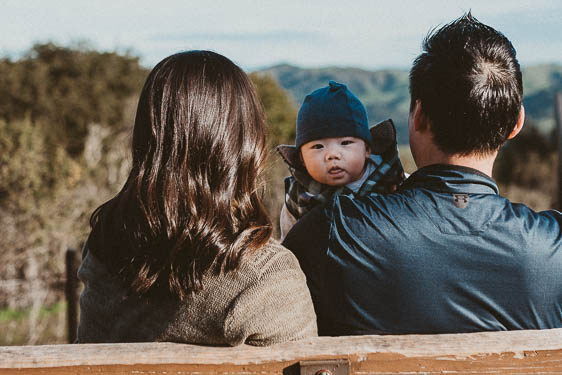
[88,51,272,299]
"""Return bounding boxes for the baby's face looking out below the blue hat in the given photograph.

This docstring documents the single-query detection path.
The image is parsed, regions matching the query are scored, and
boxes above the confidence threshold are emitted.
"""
[301,137,370,186]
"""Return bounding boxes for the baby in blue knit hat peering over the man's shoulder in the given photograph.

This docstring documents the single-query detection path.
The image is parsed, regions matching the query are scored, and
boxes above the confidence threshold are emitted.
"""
[277,81,404,240]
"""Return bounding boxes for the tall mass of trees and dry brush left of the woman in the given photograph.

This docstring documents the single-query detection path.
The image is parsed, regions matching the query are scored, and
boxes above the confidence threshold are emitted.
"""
[0,43,147,320]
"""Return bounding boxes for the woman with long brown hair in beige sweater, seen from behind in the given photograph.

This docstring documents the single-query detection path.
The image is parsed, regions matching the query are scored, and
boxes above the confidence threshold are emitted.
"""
[78,51,316,345]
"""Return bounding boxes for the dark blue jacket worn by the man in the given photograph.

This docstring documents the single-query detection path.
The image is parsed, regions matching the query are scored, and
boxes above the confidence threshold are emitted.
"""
[283,165,562,335]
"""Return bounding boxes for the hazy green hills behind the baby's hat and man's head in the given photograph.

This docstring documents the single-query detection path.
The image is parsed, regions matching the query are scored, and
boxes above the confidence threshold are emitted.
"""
[259,64,562,144]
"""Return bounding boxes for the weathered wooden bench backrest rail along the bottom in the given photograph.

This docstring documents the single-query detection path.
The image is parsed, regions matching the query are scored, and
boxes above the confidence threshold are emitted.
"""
[0,328,562,375]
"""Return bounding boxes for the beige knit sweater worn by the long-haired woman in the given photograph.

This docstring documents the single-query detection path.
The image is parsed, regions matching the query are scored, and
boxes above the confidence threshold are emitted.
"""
[78,241,317,346]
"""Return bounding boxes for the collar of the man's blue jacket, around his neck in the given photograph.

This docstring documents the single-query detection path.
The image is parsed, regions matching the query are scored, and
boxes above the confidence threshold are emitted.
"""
[400,164,499,194]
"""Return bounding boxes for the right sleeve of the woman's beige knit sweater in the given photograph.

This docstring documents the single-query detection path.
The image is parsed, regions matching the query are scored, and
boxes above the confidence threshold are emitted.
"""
[224,248,317,346]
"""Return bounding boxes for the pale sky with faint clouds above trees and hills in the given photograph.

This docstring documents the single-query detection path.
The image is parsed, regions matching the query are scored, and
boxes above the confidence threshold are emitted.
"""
[0,0,562,70]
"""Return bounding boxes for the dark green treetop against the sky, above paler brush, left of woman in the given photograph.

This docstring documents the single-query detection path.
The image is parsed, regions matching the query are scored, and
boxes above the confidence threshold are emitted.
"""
[0,43,147,157]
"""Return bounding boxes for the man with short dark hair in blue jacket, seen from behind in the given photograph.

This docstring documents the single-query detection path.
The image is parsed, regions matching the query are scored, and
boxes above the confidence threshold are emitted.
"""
[284,13,562,335]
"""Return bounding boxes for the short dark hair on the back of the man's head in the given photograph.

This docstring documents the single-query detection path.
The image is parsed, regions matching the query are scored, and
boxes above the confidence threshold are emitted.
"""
[410,12,523,155]
